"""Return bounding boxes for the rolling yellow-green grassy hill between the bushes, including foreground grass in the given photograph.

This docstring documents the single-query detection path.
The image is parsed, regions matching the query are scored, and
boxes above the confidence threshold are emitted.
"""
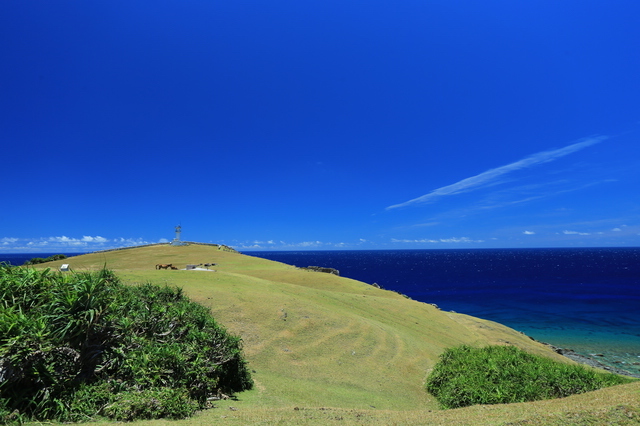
[39,245,640,424]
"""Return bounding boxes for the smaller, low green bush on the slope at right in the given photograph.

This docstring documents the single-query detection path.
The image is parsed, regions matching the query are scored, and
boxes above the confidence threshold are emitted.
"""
[426,345,631,408]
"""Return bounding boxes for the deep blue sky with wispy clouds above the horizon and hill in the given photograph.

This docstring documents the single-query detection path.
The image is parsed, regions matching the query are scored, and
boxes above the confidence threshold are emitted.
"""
[0,0,640,253]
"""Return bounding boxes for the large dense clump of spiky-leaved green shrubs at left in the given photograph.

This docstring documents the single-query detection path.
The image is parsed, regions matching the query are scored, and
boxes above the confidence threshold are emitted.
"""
[0,265,253,423]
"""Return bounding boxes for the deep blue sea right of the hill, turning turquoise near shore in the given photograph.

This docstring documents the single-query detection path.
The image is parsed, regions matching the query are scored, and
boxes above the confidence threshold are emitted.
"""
[246,248,640,374]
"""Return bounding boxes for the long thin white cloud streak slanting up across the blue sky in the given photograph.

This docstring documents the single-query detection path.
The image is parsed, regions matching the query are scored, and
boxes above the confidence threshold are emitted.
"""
[386,136,607,210]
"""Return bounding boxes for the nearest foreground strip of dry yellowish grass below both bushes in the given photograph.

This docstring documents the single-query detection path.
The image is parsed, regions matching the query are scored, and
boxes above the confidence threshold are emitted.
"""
[92,382,640,426]
